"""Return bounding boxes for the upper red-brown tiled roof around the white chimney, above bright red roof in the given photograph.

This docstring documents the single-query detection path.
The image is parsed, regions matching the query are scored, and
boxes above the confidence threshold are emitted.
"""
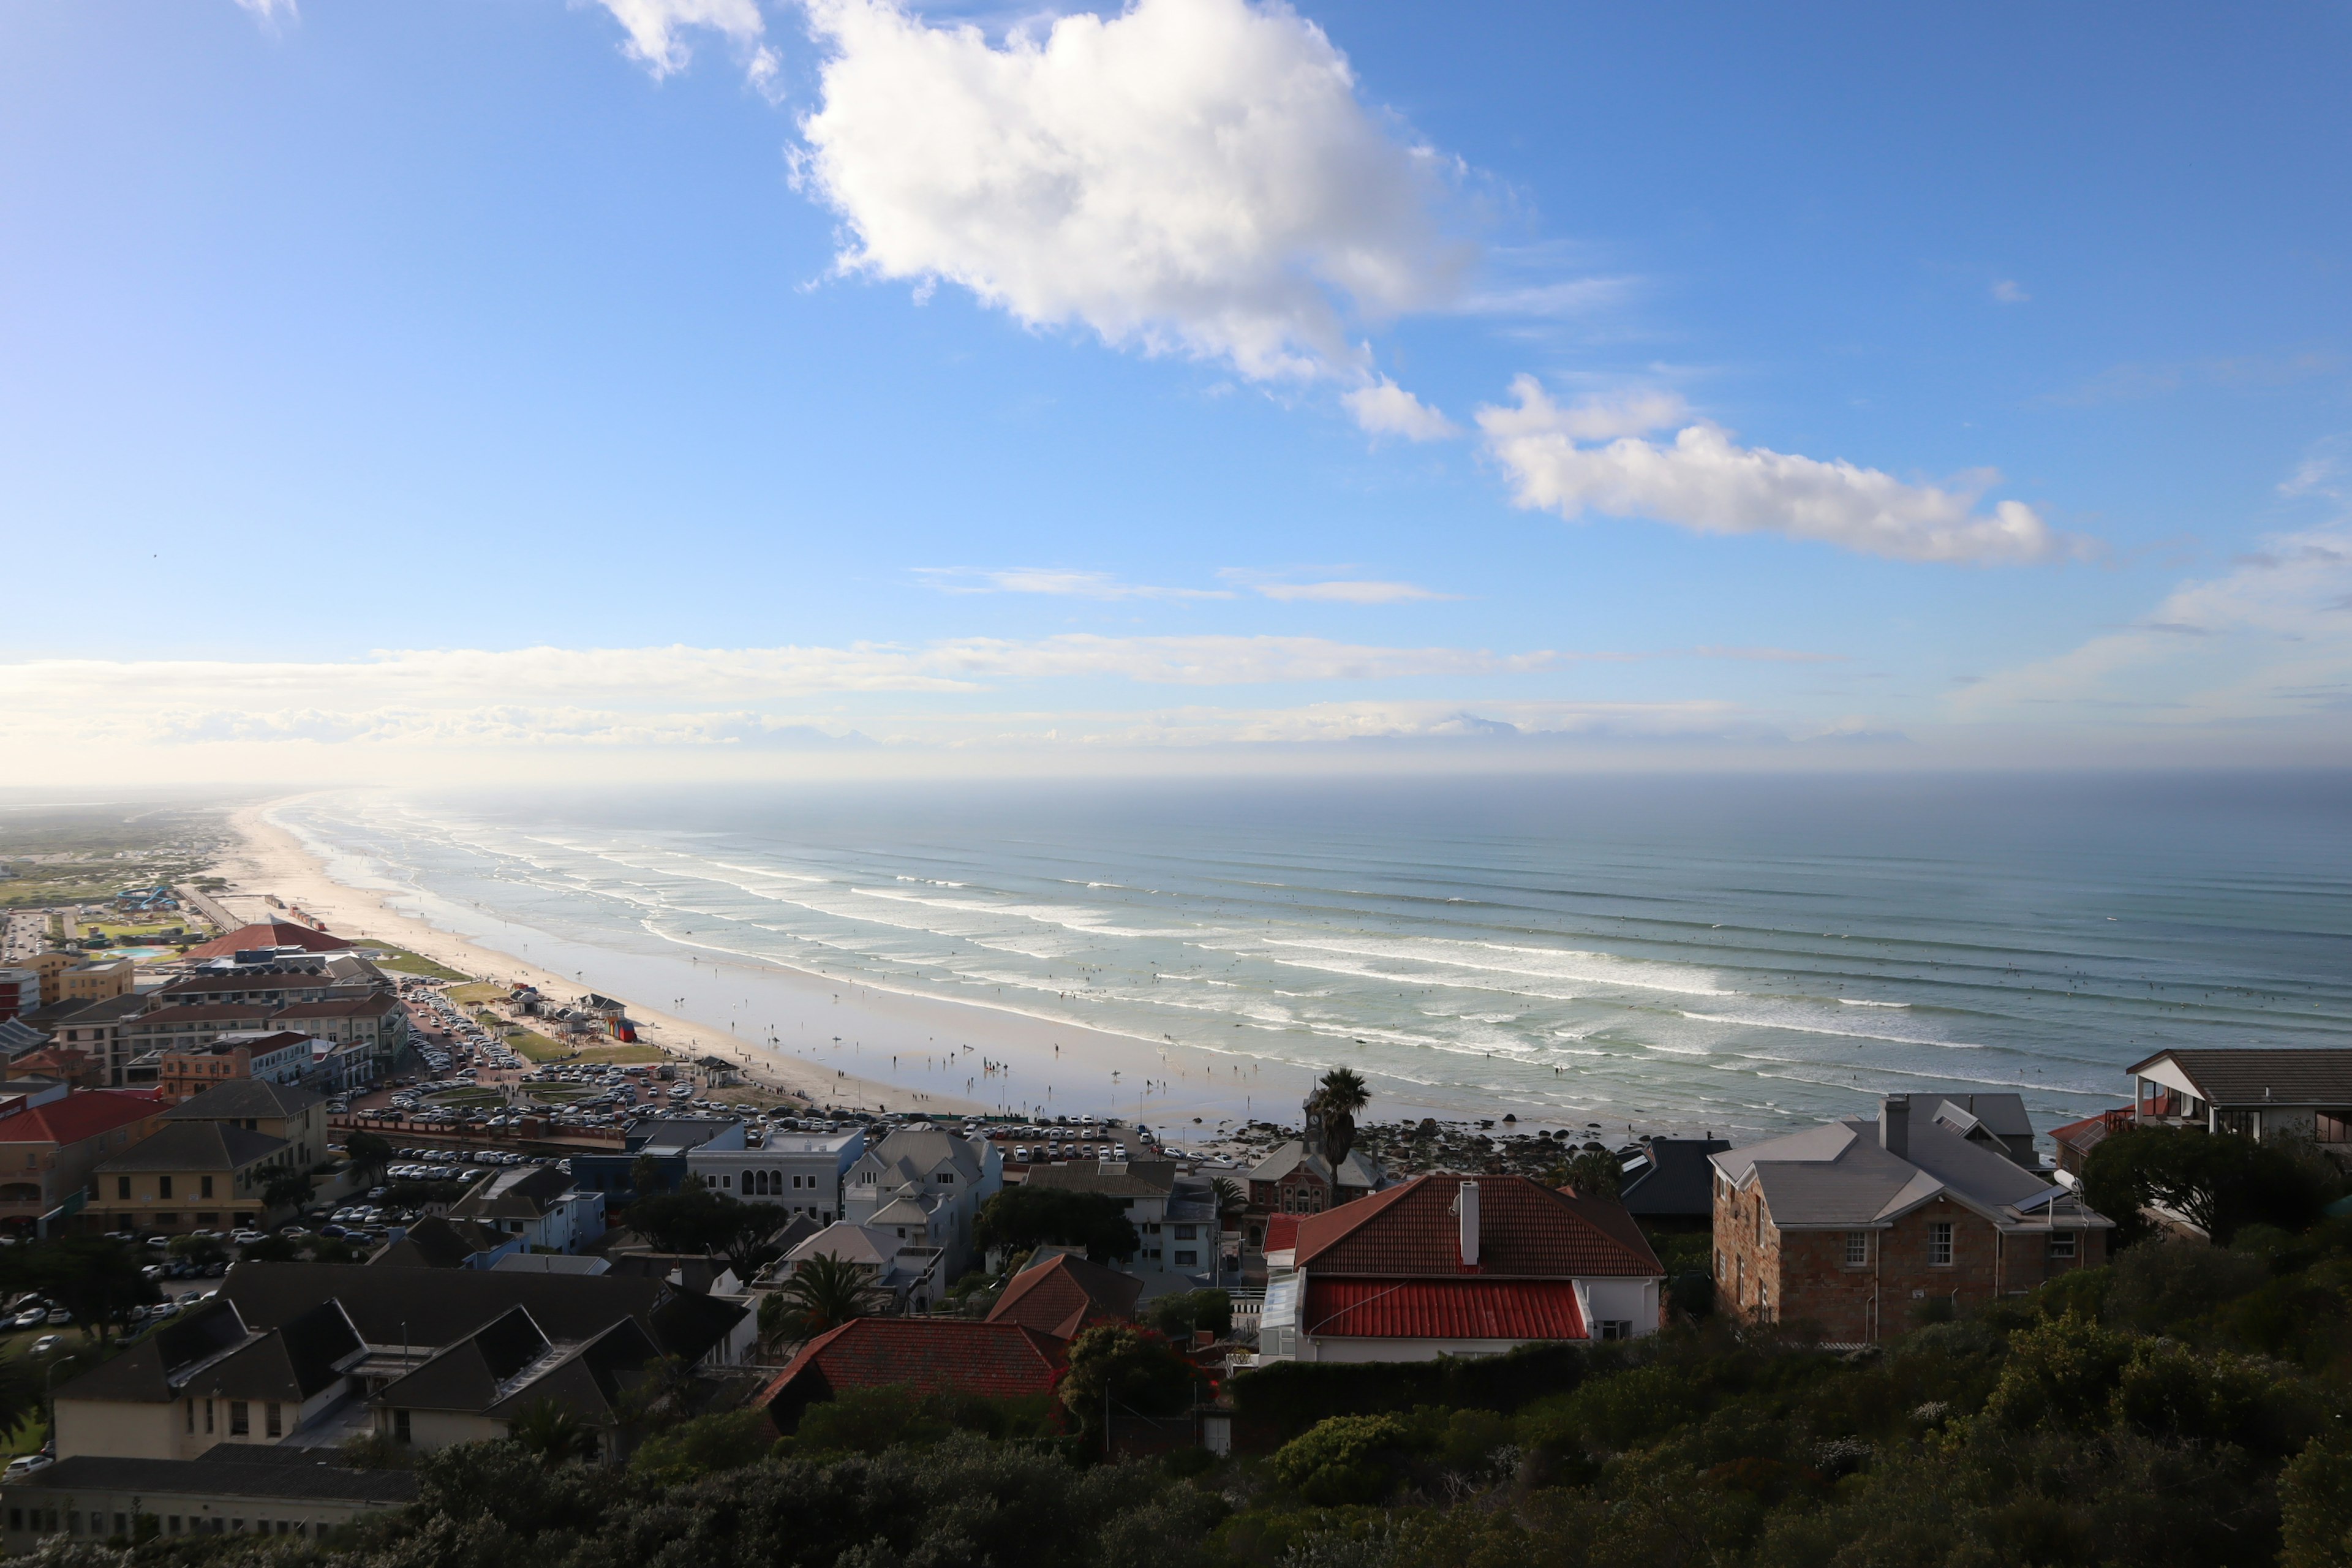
[1296,1173,1665,1279]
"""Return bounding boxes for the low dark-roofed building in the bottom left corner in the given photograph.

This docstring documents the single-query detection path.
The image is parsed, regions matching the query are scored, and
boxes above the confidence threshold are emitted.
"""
[0,1446,417,1556]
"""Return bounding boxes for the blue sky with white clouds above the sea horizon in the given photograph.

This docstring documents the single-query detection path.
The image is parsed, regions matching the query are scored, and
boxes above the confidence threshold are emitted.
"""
[0,0,2352,783]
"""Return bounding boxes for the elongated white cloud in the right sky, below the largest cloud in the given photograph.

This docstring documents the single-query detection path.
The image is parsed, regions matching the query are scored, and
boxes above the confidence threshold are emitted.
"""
[1477,376,2091,567]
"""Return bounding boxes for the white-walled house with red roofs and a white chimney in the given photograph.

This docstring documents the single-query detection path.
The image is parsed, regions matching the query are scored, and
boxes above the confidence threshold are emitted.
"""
[1258,1173,1665,1361]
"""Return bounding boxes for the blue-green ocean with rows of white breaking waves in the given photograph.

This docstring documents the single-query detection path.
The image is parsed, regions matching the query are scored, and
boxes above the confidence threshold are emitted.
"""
[273,774,2352,1140]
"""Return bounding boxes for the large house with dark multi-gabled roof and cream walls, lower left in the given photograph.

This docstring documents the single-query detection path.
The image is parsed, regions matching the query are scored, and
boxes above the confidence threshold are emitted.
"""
[54,1262,753,1460]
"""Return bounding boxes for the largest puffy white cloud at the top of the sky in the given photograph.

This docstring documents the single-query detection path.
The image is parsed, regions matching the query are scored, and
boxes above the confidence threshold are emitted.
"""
[797,0,1470,383]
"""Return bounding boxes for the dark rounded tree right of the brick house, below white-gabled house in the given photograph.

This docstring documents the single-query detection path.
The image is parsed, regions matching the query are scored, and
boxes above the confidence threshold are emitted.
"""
[2081,1126,2331,1246]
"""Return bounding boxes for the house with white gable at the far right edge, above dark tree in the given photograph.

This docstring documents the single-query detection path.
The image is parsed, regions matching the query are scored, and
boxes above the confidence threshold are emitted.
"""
[2126,1046,2352,1152]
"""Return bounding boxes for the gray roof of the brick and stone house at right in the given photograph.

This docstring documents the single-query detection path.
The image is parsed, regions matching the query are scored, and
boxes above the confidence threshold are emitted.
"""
[1710,1117,2108,1229]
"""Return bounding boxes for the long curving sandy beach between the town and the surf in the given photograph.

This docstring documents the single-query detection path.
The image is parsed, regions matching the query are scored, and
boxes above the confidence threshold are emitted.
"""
[214,802,1308,1142]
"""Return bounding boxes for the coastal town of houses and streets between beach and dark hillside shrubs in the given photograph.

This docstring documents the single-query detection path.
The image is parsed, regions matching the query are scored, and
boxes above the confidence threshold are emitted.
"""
[0,865,2352,1554]
